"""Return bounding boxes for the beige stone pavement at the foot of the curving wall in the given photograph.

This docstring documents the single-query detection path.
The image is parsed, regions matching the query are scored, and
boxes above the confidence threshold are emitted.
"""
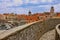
[40,30,55,40]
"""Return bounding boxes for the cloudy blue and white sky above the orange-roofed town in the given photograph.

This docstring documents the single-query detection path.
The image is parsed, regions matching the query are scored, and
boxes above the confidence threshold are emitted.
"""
[0,0,60,14]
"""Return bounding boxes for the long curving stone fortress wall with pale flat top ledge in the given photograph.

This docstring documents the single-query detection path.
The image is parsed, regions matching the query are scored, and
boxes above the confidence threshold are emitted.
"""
[0,19,60,40]
